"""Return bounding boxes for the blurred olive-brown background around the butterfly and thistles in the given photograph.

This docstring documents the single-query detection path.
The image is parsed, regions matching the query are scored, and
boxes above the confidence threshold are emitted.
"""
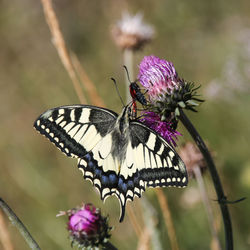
[0,0,250,250]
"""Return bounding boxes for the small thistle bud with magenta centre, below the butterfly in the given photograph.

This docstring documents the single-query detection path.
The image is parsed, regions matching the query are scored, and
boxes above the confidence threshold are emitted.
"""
[59,204,112,249]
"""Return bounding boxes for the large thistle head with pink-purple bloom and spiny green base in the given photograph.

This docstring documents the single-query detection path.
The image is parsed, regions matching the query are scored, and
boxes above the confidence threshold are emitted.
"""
[138,55,202,124]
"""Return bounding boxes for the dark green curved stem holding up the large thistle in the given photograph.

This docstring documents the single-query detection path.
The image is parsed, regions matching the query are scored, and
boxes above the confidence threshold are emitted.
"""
[180,109,233,250]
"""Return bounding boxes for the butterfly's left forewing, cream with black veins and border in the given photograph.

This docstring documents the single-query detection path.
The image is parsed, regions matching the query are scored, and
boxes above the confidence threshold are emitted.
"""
[34,105,117,158]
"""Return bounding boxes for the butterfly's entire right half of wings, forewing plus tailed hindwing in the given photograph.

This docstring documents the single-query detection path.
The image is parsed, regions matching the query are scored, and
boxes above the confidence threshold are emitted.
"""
[113,121,188,221]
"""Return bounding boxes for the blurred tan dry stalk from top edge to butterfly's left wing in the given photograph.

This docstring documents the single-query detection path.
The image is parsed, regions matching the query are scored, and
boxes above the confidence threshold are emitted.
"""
[41,0,86,103]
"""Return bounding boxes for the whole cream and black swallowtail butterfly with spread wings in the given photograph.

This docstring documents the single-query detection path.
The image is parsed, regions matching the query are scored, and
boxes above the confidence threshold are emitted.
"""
[34,105,188,222]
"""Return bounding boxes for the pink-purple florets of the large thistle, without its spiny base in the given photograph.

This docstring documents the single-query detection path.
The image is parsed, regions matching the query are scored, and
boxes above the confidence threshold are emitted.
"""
[138,55,179,102]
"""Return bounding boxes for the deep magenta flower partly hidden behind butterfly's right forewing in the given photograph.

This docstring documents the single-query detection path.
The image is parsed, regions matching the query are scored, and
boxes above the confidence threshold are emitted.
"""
[140,111,181,146]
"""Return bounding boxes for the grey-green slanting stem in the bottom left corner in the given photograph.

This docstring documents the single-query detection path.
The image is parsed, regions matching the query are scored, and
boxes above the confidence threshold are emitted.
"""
[0,198,40,250]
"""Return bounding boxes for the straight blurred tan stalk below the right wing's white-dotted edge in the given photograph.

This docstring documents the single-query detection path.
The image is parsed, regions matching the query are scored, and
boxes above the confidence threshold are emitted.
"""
[156,188,179,250]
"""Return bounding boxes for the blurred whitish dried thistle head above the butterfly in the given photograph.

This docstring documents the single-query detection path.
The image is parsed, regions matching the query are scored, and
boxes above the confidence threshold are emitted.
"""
[111,12,154,50]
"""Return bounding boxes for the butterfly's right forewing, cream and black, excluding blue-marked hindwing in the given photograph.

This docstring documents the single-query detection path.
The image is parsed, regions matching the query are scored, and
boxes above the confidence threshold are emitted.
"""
[130,122,188,187]
